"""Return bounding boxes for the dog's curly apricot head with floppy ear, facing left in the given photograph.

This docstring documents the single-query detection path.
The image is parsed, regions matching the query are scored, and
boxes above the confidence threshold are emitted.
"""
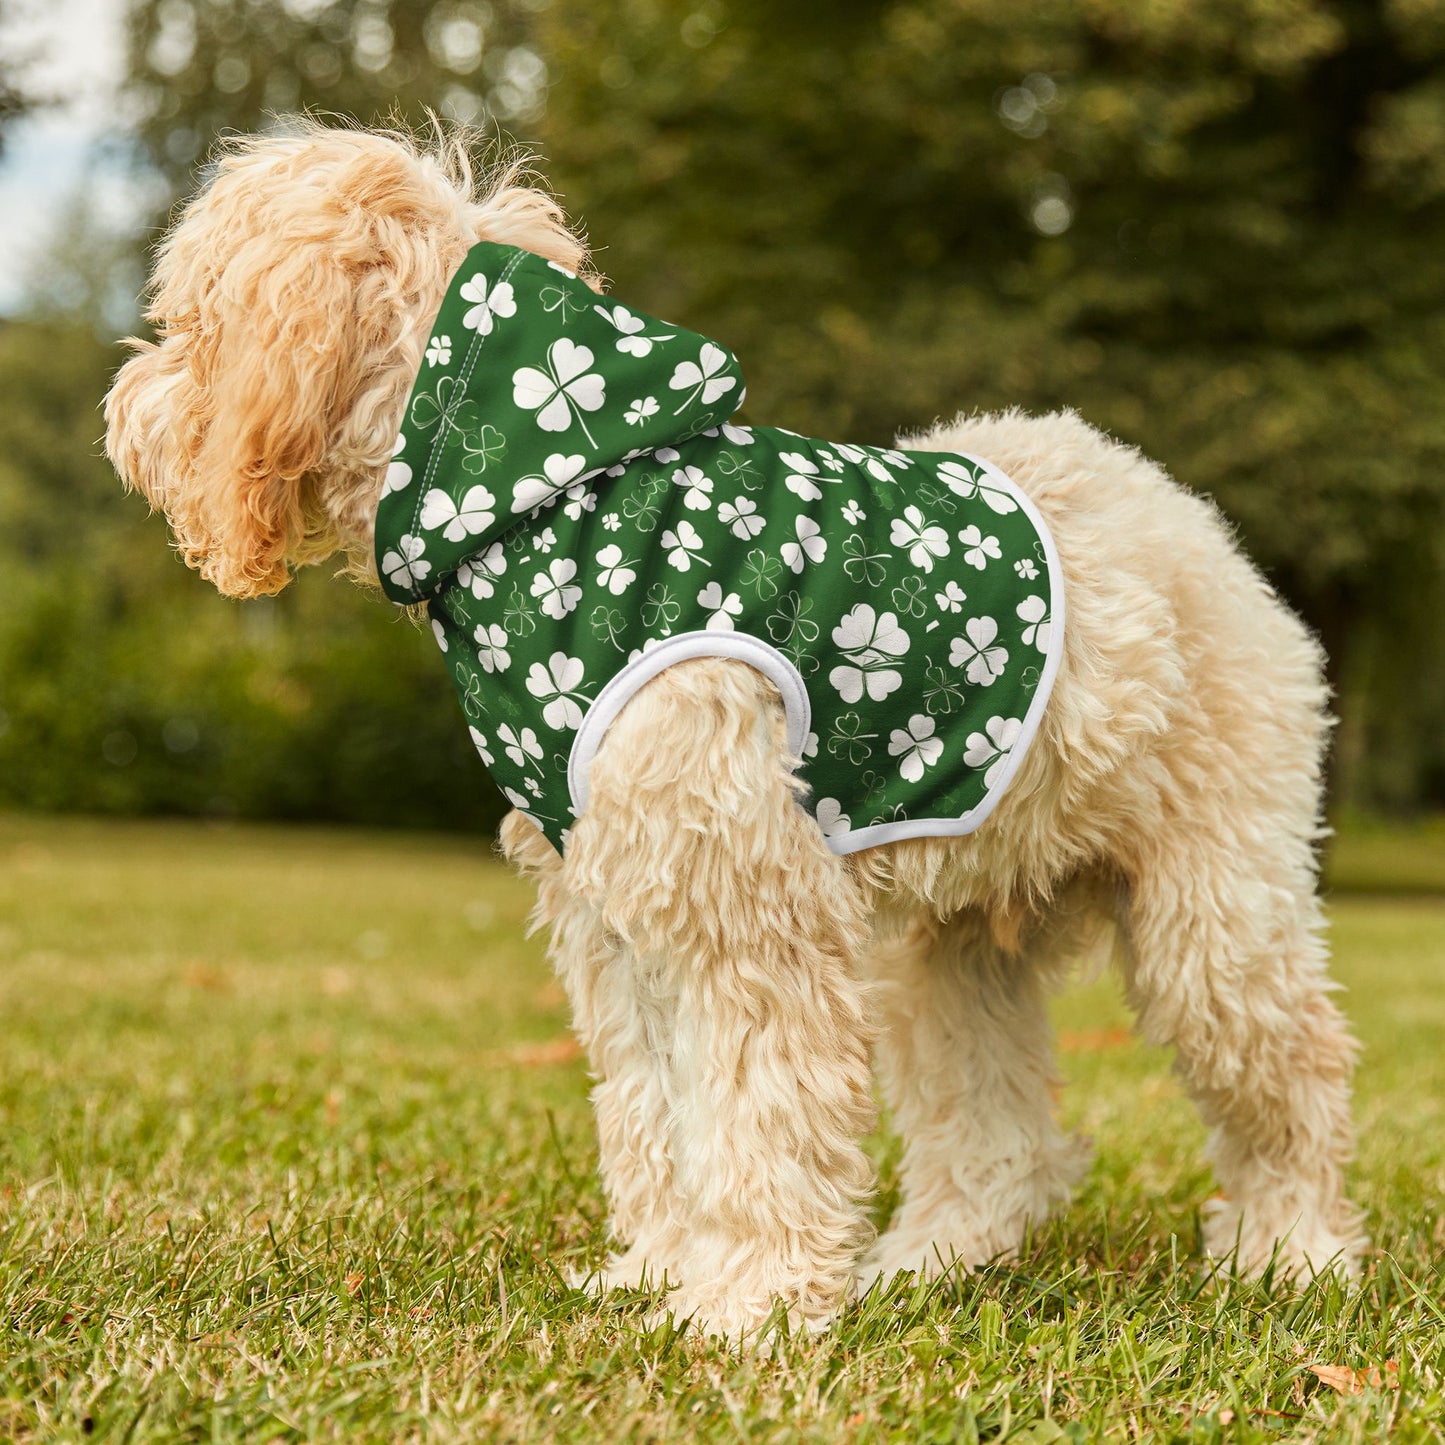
[105,123,587,597]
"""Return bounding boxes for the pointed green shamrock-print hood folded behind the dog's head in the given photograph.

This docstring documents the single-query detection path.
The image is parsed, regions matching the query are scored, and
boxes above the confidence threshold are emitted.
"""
[376,241,743,605]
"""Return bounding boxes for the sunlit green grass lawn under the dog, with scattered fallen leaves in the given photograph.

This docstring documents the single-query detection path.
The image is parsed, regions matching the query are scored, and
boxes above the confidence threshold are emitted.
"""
[0,816,1445,1445]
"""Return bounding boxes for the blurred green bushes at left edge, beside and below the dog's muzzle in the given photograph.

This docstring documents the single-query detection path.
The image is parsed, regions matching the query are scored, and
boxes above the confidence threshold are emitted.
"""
[0,315,504,831]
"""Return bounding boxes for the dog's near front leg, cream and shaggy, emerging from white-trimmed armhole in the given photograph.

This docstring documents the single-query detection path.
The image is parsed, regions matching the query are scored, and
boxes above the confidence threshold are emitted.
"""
[568,660,874,1340]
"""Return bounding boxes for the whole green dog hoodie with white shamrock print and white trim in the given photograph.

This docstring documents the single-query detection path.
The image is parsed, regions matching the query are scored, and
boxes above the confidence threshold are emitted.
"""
[376,243,1062,853]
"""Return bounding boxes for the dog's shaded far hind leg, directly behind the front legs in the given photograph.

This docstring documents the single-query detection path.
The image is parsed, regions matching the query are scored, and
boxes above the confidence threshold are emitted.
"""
[860,910,1088,1285]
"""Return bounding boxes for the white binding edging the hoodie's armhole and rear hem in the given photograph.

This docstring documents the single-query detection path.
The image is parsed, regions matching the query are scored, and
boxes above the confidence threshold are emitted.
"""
[566,452,1064,855]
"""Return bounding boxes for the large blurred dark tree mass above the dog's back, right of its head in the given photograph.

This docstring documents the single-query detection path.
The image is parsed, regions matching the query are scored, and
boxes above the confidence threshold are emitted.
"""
[538,0,1445,801]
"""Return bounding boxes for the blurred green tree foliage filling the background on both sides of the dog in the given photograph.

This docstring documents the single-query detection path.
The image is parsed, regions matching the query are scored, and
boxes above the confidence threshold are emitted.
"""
[0,0,1445,821]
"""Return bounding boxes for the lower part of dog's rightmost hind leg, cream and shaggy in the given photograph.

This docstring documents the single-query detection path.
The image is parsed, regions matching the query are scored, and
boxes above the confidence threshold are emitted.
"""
[1126,818,1364,1274]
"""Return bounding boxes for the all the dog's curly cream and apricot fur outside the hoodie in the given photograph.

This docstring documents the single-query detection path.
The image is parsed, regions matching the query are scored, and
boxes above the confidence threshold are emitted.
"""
[105,126,1363,1338]
